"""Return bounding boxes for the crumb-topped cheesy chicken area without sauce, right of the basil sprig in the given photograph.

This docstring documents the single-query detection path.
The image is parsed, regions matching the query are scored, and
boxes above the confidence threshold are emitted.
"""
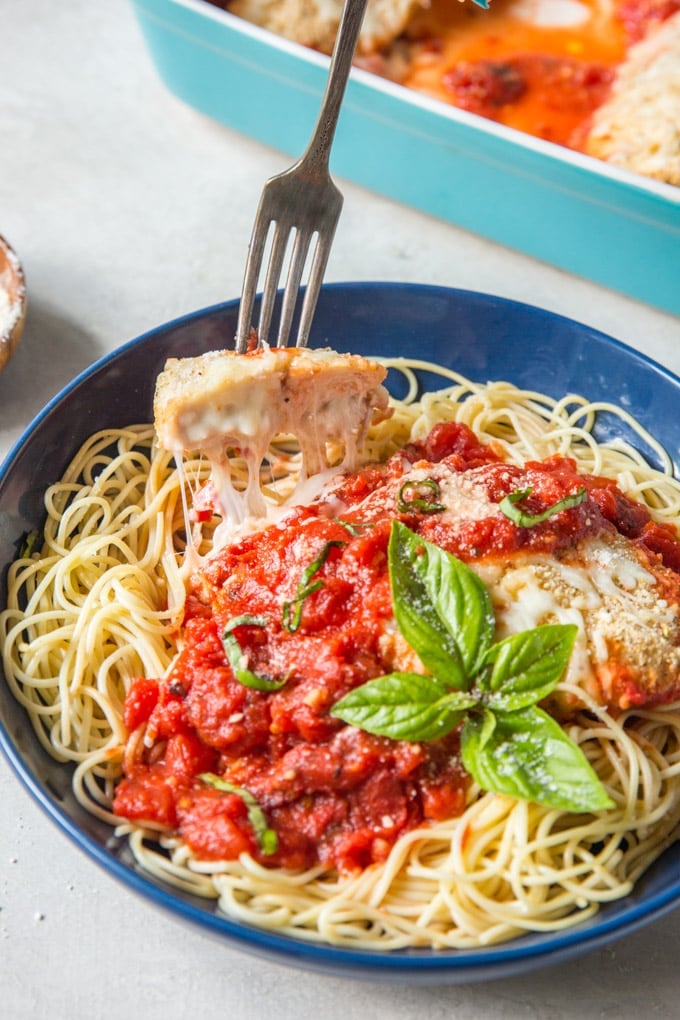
[475,532,680,709]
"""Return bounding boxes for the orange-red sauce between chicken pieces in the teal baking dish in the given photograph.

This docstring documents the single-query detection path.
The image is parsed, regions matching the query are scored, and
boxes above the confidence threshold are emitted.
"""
[383,0,628,147]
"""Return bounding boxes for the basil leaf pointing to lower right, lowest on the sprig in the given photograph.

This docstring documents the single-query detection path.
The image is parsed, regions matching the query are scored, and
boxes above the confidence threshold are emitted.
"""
[461,707,614,811]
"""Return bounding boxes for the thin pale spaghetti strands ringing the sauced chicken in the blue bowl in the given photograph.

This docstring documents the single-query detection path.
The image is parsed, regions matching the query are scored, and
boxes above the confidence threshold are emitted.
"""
[0,359,680,950]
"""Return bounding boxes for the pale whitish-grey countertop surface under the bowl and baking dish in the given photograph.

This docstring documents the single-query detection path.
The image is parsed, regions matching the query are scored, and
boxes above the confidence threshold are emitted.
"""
[0,0,680,1020]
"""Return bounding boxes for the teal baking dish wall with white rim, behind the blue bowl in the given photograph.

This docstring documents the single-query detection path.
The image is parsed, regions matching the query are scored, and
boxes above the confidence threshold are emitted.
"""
[132,0,680,315]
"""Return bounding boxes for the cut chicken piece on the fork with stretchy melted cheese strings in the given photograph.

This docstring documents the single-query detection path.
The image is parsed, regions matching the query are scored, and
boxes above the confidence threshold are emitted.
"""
[154,347,391,523]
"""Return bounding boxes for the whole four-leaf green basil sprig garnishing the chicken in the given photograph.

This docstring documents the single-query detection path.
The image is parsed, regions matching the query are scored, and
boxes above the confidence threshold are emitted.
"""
[330,522,614,812]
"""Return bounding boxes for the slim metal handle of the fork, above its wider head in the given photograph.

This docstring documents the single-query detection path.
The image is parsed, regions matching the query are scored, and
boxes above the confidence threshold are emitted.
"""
[298,0,368,172]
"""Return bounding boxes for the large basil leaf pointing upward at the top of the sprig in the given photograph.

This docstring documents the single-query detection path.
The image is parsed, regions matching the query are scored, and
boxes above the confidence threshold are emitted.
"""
[388,521,495,691]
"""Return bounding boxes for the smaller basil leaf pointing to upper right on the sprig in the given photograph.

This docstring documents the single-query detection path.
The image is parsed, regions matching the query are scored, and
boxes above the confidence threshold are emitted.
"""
[477,623,578,712]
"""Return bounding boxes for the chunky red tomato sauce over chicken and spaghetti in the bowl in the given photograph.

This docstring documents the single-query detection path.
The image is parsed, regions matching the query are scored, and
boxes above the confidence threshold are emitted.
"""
[114,424,680,872]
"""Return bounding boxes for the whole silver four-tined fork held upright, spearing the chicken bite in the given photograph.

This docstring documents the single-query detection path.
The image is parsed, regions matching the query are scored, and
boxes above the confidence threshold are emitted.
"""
[236,0,367,354]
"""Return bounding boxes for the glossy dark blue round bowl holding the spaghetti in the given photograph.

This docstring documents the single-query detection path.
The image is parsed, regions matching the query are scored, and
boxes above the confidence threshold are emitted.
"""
[0,284,680,984]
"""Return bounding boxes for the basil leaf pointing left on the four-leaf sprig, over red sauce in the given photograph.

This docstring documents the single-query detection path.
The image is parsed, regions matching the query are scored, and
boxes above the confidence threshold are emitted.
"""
[330,673,477,741]
